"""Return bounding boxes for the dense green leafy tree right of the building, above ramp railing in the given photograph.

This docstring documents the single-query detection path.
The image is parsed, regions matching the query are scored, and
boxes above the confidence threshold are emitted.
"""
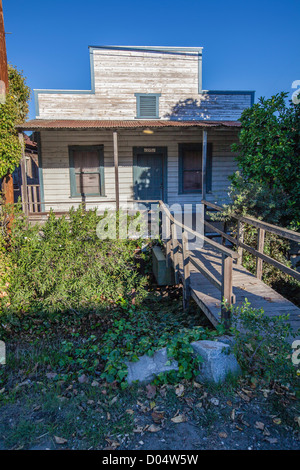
[231,93,300,230]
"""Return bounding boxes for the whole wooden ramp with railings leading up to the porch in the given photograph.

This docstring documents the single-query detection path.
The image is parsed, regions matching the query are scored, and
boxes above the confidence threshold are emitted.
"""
[160,201,300,338]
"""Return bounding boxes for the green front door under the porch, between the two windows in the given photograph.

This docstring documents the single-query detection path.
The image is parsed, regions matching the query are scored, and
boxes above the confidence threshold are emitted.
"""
[133,147,166,201]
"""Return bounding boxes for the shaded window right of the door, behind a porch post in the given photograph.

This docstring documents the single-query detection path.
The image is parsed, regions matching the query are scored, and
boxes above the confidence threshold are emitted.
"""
[179,143,212,193]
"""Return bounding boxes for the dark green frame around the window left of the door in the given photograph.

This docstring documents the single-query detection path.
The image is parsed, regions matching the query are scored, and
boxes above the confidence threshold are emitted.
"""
[68,145,105,197]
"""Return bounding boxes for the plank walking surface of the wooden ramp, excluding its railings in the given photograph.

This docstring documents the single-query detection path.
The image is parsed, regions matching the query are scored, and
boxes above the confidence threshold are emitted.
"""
[188,247,300,331]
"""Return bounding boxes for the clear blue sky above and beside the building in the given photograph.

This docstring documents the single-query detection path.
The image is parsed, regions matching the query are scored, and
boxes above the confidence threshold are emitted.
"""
[3,0,300,118]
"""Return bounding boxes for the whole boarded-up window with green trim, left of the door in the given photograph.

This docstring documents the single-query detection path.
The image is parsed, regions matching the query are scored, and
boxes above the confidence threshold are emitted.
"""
[69,145,104,196]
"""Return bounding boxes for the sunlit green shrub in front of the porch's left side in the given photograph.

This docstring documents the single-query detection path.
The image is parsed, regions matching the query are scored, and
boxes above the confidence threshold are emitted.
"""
[2,208,146,314]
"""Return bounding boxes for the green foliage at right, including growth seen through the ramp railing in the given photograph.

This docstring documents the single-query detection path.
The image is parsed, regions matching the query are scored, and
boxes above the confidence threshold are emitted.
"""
[212,93,300,306]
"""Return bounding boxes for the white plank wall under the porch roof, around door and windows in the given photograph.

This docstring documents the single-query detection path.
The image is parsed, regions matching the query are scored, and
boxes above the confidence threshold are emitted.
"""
[41,129,237,210]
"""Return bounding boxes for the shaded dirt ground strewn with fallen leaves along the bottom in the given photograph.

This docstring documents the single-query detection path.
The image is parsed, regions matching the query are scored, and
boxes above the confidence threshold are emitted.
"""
[0,379,300,450]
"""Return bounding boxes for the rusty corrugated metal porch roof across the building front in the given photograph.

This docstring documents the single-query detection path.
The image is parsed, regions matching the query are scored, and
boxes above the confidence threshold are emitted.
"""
[17,119,241,131]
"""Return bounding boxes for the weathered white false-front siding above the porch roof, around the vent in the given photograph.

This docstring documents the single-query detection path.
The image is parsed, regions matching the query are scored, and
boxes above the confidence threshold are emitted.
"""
[36,48,252,120]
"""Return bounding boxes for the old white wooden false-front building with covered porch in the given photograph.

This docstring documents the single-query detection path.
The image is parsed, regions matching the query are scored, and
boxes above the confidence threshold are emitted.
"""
[20,46,254,211]
